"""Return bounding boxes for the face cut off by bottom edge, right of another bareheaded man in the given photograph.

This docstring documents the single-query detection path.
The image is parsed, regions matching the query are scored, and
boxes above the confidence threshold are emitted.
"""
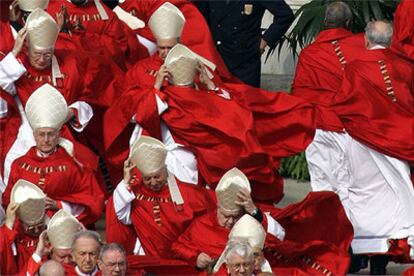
[98,250,127,276]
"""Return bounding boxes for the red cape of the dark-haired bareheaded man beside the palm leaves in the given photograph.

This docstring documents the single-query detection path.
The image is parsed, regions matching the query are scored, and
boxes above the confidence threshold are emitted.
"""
[292,28,365,131]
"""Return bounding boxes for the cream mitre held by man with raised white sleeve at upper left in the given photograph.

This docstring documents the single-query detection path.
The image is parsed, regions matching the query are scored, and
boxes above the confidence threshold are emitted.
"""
[26,8,59,50]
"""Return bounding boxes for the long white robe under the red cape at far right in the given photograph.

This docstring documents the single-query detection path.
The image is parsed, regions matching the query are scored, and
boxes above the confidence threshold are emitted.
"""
[306,130,414,254]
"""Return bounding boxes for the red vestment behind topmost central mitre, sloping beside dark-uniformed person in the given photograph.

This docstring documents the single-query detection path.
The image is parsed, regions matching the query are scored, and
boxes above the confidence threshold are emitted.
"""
[119,0,235,80]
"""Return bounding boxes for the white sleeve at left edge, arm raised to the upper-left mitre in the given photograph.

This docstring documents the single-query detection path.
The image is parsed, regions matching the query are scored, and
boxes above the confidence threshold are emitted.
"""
[0,52,26,95]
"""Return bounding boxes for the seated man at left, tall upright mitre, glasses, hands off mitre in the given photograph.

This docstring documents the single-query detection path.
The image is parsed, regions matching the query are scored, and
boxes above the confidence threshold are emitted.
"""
[3,84,103,225]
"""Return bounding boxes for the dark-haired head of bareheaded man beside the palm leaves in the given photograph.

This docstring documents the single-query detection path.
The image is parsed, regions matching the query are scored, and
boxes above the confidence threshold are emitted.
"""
[325,2,352,28]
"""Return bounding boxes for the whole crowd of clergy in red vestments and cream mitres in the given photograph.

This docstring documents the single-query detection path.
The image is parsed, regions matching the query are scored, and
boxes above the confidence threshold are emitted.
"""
[0,0,414,275]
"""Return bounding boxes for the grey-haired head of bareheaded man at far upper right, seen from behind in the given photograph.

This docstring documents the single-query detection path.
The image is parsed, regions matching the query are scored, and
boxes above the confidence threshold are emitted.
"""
[365,21,393,47]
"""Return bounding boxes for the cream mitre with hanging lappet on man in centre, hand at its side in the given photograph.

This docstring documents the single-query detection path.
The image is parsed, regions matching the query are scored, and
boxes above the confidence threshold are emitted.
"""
[129,135,184,205]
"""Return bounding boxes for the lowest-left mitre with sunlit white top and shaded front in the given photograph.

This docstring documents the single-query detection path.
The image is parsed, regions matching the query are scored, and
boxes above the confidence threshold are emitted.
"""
[10,179,46,225]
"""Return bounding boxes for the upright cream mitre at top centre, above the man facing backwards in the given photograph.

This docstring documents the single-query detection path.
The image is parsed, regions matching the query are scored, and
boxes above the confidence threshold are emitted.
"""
[148,2,185,40]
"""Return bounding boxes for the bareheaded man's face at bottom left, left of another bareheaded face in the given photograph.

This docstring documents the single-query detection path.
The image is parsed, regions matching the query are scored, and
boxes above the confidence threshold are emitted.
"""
[72,237,100,273]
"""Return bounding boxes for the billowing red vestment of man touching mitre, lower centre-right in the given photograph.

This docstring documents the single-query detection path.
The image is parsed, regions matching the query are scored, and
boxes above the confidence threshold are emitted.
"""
[172,192,353,275]
